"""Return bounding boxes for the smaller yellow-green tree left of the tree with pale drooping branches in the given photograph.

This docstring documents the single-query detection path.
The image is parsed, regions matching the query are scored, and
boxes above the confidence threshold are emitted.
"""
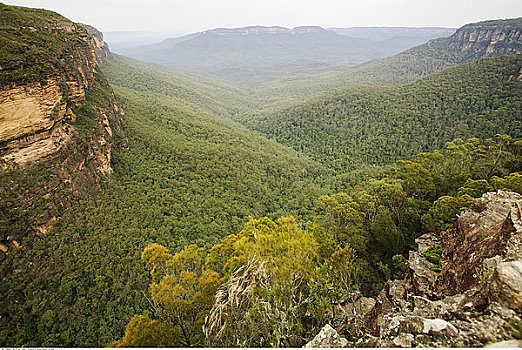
[115,243,220,347]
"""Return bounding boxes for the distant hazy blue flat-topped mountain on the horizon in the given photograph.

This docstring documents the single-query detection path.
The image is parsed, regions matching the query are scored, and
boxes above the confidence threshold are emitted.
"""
[120,26,450,82]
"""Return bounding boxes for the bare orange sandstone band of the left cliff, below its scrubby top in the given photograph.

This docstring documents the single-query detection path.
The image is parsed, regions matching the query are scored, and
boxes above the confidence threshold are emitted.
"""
[0,23,107,168]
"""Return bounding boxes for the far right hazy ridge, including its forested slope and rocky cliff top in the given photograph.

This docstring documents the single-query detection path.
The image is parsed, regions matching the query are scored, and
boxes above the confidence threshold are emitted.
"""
[246,18,522,105]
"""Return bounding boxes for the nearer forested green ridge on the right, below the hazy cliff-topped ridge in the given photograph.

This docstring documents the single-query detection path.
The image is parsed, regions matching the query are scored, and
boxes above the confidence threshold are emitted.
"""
[245,54,522,170]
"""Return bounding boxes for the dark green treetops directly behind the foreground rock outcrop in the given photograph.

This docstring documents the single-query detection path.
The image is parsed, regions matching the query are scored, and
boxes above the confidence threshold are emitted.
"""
[306,135,521,294]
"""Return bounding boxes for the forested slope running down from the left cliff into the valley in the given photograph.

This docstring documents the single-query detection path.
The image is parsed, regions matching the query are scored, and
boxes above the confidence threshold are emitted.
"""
[0,50,328,346]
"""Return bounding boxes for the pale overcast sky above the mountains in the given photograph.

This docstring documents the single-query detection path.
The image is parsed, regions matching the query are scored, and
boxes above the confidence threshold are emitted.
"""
[3,0,522,33]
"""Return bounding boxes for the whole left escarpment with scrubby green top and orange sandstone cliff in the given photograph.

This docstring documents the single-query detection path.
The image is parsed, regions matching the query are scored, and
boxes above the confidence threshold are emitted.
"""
[0,4,123,255]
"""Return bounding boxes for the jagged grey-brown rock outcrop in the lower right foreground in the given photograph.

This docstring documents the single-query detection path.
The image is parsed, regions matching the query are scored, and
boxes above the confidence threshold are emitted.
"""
[308,191,522,347]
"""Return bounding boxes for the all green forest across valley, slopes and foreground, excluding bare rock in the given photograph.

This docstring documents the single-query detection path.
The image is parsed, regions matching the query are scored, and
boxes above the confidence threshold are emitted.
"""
[0,4,522,347]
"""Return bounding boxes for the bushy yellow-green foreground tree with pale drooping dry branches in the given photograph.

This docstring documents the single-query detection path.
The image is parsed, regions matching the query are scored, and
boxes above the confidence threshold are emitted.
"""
[205,217,356,347]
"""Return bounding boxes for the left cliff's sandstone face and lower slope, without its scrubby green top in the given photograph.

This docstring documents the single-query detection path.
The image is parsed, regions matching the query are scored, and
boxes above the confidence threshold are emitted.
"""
[0,19,123,259]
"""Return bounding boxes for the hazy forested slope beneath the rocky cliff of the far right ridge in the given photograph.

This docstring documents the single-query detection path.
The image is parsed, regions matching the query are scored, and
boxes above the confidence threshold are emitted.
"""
[241,18,521,106]
